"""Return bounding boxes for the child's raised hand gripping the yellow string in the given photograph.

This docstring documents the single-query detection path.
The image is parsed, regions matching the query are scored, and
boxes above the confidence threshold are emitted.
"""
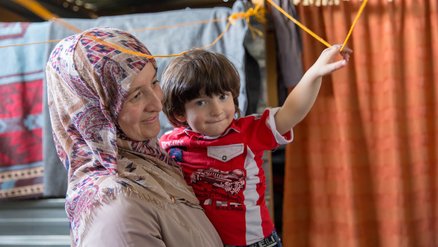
[309,45,353,76]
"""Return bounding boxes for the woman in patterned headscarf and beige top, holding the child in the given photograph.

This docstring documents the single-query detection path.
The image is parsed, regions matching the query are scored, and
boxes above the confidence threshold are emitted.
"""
[46,28,222,247]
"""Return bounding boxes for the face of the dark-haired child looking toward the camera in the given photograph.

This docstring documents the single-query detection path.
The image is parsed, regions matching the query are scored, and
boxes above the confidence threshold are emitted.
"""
[177,92,236,136]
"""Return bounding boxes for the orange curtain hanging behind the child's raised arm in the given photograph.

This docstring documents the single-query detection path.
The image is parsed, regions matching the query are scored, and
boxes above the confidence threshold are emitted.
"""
[283,0,438,247]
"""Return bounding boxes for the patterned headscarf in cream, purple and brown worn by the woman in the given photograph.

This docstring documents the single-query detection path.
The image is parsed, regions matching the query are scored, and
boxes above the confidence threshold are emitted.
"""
[46,28,198,245]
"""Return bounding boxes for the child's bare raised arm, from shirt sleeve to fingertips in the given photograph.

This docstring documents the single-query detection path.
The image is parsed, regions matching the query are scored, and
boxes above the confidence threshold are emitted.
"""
[275,45,352,134]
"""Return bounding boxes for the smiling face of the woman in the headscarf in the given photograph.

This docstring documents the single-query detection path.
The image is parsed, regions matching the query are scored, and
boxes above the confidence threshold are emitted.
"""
[117,63,163,141]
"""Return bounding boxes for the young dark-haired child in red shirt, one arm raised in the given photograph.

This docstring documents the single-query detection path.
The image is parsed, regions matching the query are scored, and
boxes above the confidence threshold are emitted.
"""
[161,45,351,246]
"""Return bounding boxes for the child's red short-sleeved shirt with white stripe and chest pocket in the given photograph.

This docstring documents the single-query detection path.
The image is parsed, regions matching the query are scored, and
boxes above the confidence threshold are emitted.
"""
[160,108,293,245]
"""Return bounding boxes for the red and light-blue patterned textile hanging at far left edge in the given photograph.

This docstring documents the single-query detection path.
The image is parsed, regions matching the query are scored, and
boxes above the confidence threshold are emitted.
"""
[0,23,49,199]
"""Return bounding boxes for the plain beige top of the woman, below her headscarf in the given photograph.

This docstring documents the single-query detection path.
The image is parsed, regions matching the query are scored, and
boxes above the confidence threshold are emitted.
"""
[80,196,223,247]
